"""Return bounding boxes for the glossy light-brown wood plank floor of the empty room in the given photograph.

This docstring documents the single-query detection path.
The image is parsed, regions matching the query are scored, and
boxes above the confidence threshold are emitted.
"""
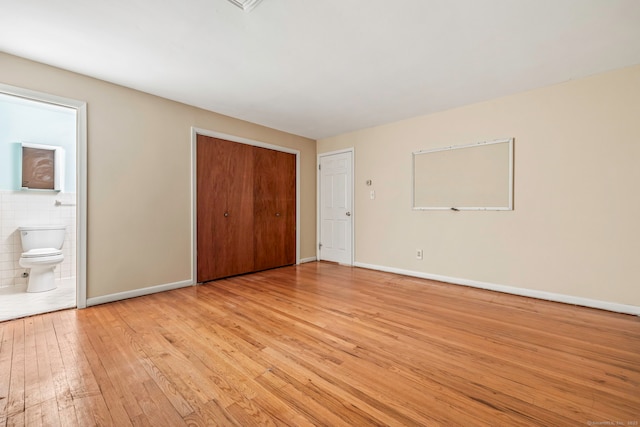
[0,263,640,426]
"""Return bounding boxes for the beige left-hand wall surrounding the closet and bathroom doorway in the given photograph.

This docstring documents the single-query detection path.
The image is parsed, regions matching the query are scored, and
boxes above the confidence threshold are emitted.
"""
[0,53,316,298]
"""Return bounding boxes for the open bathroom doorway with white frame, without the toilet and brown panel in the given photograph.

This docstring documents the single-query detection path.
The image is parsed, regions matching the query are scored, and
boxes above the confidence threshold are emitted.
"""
[0,84,86,321]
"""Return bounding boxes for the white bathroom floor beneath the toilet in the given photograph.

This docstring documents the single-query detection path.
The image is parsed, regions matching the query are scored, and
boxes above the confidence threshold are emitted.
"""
[0,279,76,322]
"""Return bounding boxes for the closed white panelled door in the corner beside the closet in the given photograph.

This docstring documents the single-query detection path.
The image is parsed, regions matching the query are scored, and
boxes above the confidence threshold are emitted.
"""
[318,151,353,265]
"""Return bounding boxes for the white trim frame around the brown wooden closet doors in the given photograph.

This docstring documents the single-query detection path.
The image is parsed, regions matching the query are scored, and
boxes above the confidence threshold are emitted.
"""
[191,127,300,283]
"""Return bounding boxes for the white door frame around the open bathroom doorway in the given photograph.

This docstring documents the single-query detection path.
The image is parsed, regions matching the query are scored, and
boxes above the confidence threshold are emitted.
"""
[0,83,87,308]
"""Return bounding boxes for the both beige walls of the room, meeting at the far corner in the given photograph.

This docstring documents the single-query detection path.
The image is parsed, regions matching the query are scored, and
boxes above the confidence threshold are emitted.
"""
[0,53,640,306]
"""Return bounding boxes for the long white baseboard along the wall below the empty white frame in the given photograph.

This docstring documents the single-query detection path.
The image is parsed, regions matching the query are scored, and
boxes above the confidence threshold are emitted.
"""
[353,262,640,316]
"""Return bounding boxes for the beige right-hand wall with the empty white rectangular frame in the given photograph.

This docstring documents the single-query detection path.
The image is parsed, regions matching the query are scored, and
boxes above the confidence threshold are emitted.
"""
[318,66,640,306]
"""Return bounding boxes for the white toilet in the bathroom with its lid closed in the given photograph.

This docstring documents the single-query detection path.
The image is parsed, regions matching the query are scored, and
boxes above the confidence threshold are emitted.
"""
[18,225,65,292]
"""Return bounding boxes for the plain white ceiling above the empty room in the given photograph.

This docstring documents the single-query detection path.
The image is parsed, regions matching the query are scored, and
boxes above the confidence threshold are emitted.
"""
[0,0,640,139]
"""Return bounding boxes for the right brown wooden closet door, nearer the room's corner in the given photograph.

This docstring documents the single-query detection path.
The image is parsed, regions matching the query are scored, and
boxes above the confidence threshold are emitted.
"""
[253,147,296,270]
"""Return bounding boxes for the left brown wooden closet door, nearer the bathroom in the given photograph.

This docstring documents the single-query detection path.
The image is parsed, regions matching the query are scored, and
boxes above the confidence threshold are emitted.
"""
[196,135,254,282]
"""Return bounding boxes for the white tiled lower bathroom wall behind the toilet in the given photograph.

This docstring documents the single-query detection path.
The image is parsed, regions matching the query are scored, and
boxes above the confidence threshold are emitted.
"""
[0,191,76,287]
